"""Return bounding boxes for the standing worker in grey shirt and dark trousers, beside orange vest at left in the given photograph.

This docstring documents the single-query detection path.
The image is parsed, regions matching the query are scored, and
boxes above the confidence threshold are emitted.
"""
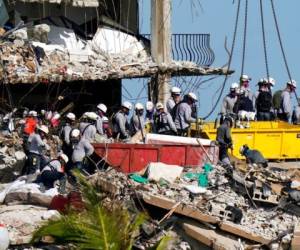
[26,125,50,175]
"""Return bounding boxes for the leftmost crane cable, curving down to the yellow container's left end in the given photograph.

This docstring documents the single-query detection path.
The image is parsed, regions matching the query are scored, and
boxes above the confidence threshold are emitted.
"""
[203,0,241,120]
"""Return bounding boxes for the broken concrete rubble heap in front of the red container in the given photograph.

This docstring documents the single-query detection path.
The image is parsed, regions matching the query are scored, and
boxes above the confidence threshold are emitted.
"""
[93,162,299,249]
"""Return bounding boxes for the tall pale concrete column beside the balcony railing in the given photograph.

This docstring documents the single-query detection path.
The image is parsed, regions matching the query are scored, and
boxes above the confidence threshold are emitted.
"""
[151,0,172,103]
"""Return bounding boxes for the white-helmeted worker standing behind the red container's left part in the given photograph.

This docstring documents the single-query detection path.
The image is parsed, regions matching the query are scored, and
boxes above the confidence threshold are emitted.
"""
[112,101,132,140]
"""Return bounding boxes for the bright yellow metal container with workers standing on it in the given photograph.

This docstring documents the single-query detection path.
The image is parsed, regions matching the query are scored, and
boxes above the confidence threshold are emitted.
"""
[191,121,300,160]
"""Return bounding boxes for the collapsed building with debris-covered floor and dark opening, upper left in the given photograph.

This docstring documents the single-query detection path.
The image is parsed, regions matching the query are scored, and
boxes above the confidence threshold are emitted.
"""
[0,0,231,115]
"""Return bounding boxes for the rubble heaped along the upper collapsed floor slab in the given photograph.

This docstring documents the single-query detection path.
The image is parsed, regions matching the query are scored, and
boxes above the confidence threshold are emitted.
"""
[0,24,232,84]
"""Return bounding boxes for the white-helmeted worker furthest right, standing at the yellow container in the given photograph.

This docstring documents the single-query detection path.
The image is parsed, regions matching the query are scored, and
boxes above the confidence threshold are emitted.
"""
[278,80,297,122]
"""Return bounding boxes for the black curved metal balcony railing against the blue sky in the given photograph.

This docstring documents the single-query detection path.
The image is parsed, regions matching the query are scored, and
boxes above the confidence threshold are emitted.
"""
[141,34,215,66]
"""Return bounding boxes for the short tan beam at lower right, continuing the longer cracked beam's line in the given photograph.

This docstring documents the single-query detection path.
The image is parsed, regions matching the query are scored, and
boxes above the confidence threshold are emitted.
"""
[219,221,272,244]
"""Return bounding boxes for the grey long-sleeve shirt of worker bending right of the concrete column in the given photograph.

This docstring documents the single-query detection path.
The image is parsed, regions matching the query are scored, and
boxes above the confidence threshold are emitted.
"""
[175,102,196,130]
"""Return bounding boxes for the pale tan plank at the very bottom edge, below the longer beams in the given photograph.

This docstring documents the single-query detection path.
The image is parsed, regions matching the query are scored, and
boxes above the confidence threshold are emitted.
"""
[182,223,240,250]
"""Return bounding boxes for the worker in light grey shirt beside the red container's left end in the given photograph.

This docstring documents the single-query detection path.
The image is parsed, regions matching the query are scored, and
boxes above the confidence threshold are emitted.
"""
[71,129,94,170]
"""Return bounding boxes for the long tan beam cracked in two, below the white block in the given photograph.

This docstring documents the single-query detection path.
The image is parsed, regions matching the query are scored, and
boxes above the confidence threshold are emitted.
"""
[143,195,219,224]
